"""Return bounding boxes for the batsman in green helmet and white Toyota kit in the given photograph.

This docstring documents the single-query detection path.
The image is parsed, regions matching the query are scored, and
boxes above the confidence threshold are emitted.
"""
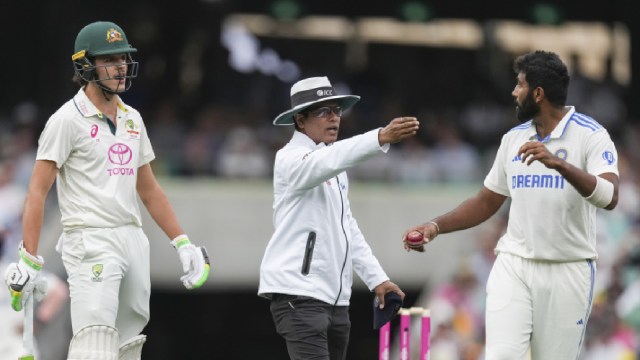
[5,21,209,360]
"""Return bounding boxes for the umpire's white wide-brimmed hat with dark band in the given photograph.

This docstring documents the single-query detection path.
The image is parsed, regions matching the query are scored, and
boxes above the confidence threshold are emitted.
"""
[273,76,360,125]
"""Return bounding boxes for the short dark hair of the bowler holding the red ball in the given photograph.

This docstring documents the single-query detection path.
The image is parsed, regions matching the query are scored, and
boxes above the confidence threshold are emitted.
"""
[513,50,570,106]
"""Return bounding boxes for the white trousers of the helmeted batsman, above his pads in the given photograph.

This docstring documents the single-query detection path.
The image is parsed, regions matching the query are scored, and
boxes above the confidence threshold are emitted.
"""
[57,226,151,343]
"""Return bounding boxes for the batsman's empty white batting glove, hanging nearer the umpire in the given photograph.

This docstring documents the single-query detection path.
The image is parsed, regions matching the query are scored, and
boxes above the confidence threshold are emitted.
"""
[171,234,210,290]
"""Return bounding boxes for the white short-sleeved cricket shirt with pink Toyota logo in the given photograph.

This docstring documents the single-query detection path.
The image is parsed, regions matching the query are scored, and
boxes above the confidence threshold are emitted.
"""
[36,89,155,231]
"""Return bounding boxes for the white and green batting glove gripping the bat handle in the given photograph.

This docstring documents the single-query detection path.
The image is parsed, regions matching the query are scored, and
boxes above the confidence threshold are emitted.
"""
[4,244,46,311]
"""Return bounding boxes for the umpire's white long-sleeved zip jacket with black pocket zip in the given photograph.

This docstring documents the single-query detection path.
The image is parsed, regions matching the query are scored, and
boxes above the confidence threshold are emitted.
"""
[258,129,389,306]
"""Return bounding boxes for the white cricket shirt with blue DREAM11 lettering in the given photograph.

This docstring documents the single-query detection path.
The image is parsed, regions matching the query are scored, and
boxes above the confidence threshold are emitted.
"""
[484,107,618,261]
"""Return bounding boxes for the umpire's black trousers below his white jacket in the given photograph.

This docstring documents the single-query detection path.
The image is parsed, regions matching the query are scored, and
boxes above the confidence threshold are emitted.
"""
[271,294,351,360]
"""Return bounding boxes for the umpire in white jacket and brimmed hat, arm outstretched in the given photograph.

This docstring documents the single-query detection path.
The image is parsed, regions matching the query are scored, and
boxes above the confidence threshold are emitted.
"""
[258,77,419,360]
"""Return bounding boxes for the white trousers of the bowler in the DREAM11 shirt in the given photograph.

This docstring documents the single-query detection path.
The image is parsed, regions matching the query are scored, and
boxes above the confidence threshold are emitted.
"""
[485,253,596,360]
